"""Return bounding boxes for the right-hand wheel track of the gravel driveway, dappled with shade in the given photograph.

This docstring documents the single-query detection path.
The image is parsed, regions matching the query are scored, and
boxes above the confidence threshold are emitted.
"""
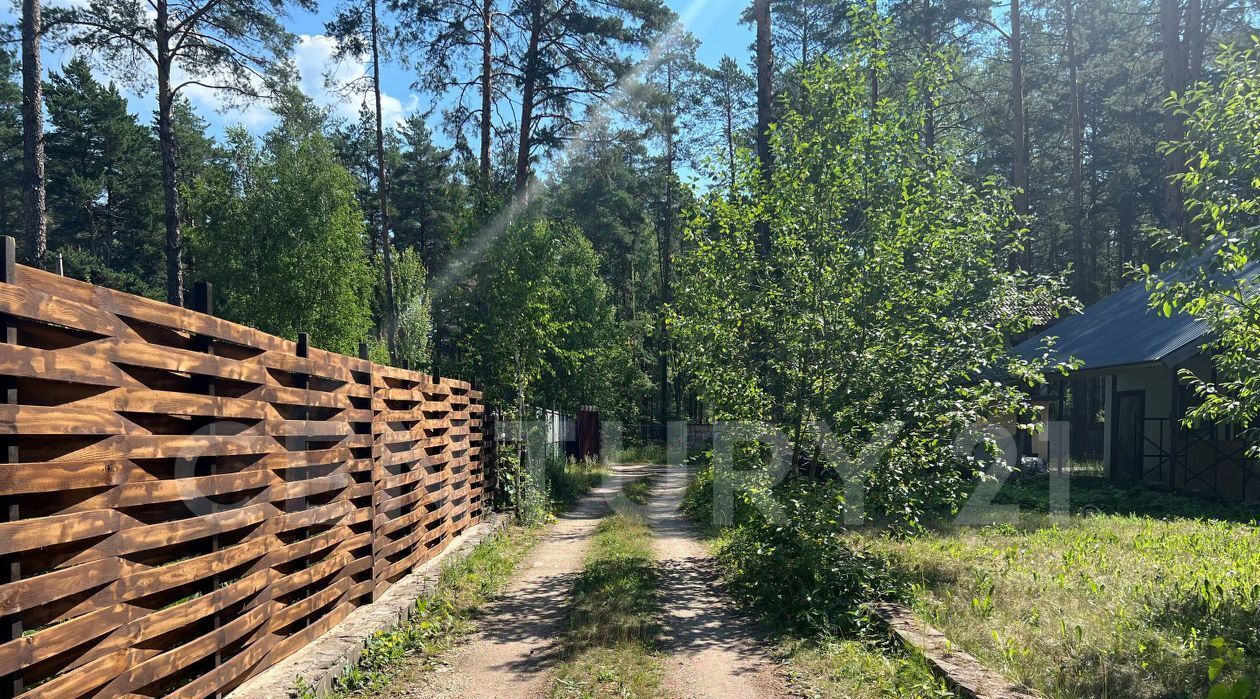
[644,466,789,699]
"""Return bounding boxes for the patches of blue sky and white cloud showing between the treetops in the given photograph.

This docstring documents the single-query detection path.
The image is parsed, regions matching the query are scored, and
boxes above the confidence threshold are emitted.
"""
[7,0,752,141]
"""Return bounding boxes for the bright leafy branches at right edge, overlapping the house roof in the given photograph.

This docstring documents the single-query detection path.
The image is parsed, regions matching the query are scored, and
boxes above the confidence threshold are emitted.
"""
[1148,38,1260,455]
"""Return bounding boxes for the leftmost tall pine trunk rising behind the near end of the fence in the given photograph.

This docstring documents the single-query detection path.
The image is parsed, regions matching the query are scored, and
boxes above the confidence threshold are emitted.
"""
[21,0,48,268]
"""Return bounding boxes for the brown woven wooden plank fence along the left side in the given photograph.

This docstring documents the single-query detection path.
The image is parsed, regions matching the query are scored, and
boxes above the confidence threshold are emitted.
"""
[0,239,491,698]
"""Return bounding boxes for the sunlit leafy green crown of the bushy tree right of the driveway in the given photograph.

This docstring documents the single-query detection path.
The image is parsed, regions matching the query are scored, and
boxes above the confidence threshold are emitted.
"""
[672,15,1068,521]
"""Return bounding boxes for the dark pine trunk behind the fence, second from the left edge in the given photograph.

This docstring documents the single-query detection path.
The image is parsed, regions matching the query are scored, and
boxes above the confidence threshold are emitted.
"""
[156,0,184,306]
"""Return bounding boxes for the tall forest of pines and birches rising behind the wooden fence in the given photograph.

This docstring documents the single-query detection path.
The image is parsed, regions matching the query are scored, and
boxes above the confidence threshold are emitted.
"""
[0,0,1256,421]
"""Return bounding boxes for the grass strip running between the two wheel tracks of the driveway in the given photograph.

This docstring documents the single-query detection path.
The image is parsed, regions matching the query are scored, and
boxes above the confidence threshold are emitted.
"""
[549,514,662,699]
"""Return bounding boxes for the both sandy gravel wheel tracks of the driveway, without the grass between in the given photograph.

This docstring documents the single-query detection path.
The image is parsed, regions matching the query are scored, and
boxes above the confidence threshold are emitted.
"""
[384,466,789,699]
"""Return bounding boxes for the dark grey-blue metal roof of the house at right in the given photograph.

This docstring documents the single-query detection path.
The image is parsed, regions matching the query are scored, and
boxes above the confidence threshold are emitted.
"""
[1014,263,1260,372]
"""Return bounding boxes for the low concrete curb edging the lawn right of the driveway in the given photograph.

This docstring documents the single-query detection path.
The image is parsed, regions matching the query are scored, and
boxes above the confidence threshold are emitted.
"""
[867,602,1041,699]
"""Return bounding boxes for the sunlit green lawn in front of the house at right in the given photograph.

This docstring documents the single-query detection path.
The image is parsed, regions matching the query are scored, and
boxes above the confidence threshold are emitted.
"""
[852,494,1260,699]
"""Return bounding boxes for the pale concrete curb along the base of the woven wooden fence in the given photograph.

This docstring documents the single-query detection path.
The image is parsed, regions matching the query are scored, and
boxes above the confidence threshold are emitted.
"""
[228,514,512,699]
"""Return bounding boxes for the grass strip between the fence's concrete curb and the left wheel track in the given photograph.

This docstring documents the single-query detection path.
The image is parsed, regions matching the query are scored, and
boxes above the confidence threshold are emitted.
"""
[315,526,538,696]
